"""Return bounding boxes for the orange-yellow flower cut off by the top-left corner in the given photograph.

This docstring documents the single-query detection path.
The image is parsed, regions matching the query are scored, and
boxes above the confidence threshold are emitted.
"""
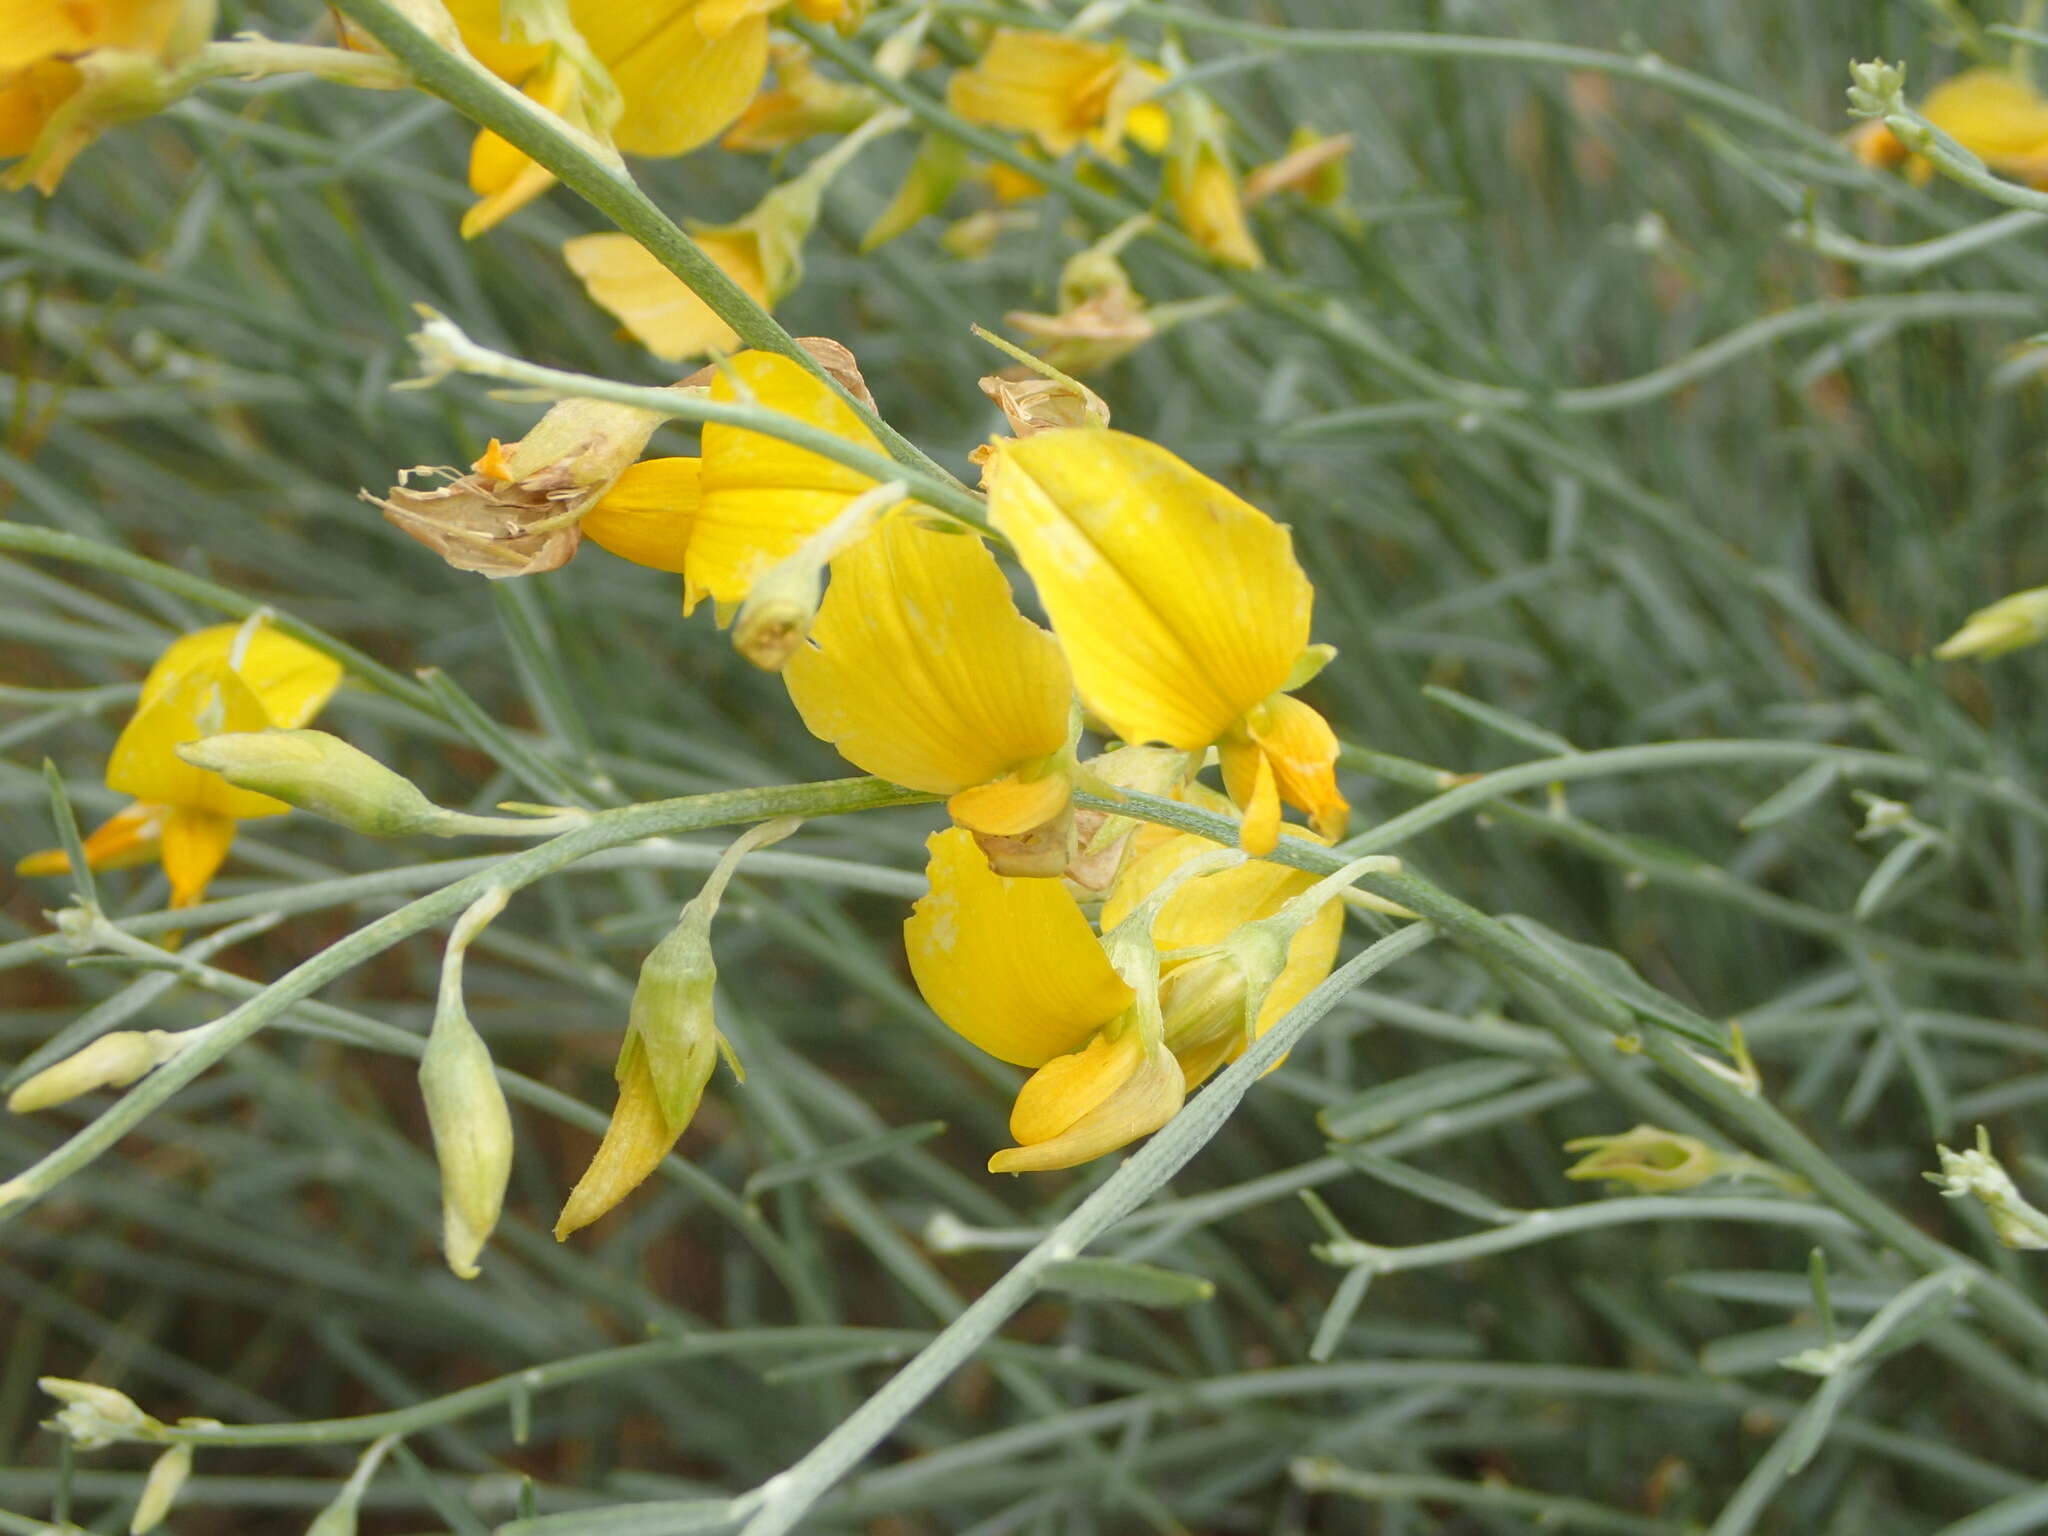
[0,0,213,193]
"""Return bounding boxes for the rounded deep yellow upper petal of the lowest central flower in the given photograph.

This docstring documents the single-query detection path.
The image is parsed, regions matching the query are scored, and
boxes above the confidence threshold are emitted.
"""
[903,827,1135,1067]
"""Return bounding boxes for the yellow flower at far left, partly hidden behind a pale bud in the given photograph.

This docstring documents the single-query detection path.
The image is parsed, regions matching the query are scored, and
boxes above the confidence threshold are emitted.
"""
[16,618,342,907]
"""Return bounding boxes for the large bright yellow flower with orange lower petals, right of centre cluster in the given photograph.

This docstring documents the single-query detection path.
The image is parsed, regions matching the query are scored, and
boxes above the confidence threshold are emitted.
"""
[987,428,1350,854]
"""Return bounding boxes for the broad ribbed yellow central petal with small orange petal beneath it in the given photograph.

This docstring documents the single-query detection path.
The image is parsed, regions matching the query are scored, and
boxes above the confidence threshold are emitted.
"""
[782,520,1073,798]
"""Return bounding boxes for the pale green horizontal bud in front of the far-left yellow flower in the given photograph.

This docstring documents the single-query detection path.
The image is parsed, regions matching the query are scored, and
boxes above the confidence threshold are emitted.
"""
[176,731,451,838]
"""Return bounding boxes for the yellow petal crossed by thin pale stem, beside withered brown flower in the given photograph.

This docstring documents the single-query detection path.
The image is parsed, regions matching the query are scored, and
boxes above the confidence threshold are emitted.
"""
[690,352,881,602]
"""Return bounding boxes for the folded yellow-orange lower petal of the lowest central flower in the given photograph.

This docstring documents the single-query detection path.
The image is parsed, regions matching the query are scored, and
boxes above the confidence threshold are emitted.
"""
[989,1034,1186,1174]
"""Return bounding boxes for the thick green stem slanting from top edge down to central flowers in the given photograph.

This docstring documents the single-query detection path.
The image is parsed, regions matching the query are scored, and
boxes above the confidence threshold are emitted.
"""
[319,0,952,493]
